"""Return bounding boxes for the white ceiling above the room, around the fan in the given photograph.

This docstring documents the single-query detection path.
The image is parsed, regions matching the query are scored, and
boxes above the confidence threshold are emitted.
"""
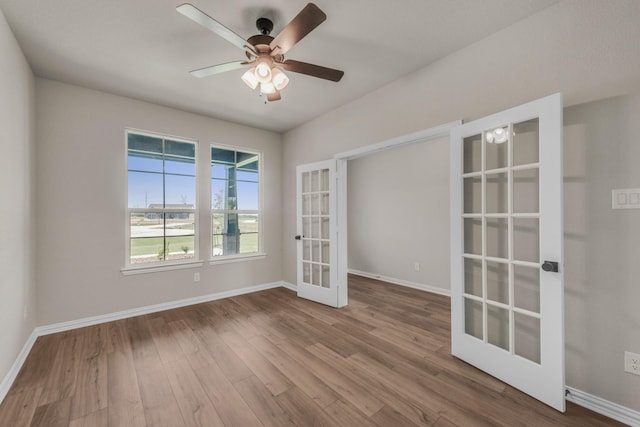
[0,0,557,132]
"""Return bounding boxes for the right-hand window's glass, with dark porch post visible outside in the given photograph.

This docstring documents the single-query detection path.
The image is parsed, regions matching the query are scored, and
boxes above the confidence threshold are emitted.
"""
[211,146,261,257]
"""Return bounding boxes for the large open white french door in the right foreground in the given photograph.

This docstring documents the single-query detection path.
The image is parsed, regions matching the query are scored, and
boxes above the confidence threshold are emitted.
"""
[451,94,565,412]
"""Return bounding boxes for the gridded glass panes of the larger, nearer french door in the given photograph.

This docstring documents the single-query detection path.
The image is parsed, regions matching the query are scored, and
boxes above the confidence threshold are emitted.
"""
[462,119,541,363]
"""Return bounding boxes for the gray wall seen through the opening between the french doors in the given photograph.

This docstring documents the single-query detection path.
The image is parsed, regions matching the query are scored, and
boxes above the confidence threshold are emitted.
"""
[347,138,449,292]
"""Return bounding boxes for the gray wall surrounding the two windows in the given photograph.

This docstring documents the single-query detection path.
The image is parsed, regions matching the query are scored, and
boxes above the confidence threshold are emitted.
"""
[36,79,282,325]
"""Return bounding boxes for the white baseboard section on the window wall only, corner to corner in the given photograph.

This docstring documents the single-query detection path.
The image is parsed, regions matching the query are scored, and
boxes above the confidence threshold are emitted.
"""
[36,282,282,336]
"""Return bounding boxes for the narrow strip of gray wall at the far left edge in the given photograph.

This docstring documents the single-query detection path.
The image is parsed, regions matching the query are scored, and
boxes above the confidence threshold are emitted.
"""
[0,12,37,390]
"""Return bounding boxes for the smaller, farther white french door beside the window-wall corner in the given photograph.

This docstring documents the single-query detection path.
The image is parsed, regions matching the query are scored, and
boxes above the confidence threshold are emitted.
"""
[295,160,346,307]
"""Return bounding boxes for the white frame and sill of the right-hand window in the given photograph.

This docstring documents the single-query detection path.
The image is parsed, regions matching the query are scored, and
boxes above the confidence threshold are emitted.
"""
[207,143,266,265]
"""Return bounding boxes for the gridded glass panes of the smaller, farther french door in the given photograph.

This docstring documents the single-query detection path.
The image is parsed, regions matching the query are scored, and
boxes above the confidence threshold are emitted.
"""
[302,169,331,288]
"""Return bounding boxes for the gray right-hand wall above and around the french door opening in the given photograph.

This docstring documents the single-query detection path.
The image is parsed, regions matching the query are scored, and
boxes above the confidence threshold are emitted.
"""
[283,0,640,410]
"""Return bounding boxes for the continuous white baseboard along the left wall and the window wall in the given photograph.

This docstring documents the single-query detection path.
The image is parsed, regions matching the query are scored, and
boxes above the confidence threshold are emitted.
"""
[0,282,288,403]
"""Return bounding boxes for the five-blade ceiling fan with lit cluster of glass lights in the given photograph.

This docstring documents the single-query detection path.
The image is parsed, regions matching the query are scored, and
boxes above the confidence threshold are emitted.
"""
[176,3,344,101]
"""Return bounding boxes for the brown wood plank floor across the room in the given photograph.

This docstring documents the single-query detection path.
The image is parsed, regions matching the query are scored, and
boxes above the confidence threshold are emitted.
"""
[0,276,622,427]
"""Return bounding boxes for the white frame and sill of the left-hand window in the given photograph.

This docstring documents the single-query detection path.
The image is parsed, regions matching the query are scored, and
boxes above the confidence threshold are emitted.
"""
[121,128,203,275]
